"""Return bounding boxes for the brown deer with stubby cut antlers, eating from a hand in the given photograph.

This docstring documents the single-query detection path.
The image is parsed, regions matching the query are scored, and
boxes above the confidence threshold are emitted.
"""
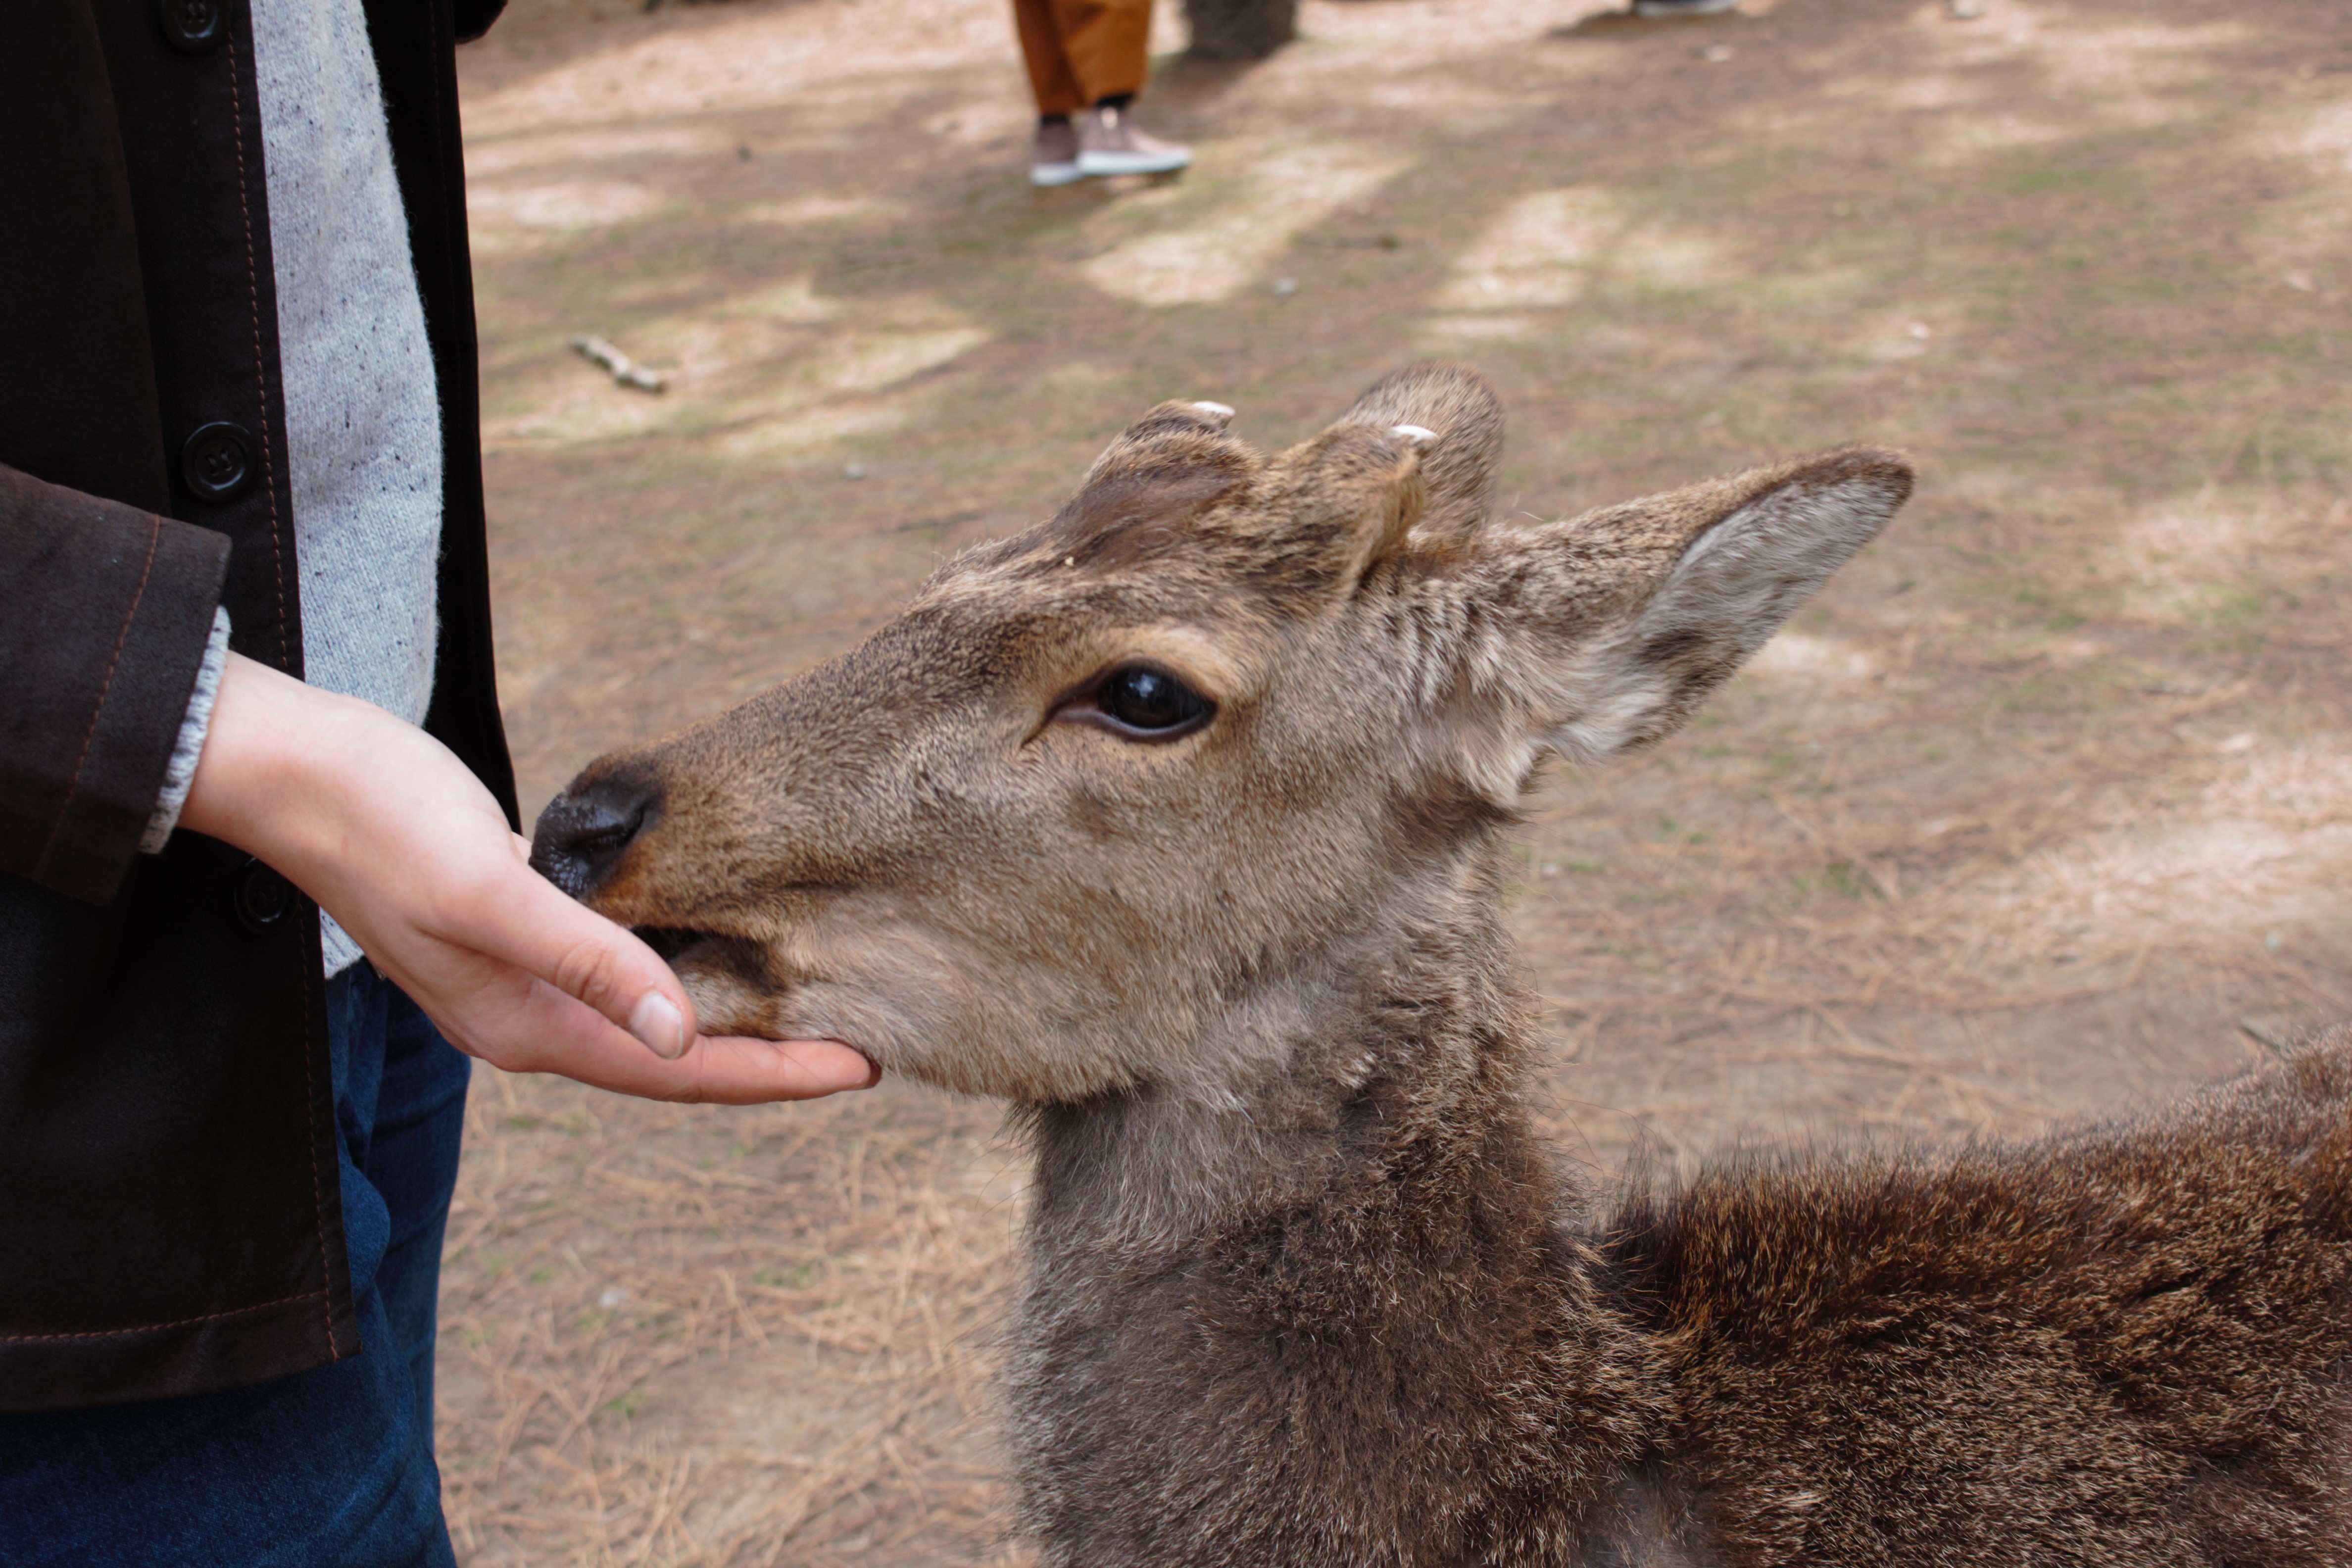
[534,362,2352,1568]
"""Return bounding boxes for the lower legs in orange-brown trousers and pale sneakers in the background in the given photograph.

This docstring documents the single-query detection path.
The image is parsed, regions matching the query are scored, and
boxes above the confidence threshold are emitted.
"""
[1014,0,1192,186]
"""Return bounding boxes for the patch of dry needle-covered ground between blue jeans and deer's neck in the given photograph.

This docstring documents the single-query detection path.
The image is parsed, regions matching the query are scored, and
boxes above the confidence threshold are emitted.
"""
[442,1077,1019,1568]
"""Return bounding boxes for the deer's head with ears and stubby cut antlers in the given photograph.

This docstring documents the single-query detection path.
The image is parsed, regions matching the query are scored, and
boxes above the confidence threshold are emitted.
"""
[532,364,1912,1105]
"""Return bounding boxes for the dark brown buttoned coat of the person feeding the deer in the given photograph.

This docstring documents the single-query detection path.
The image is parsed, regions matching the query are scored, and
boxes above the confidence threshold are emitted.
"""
[0,0,513,1411]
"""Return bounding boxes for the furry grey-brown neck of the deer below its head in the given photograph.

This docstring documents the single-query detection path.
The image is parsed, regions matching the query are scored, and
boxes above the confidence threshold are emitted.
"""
[1014,851,1646,1564]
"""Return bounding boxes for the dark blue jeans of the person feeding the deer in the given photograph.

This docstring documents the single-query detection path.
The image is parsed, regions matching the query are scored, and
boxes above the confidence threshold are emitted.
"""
[0,962,470,1568]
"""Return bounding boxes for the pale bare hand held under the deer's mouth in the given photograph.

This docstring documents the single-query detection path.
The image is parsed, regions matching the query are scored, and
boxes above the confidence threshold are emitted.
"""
[179,653,880,1105]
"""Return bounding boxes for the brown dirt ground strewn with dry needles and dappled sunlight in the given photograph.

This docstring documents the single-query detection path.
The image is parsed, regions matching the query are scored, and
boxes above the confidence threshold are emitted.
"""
[442,0,2352,1568]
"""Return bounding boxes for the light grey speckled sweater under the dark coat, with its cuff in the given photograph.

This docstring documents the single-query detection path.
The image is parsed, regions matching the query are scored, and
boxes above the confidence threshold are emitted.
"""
[146,0,442,976]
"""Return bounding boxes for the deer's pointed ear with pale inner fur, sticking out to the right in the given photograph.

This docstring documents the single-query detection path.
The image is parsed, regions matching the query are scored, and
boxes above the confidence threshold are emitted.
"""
[1461,446,1912,797]
